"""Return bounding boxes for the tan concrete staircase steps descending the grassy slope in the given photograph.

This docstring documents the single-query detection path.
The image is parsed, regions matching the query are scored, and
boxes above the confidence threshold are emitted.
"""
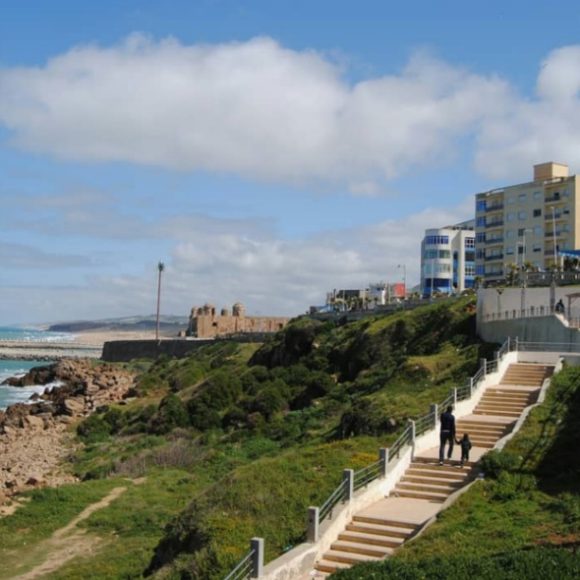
[310,363,553,578]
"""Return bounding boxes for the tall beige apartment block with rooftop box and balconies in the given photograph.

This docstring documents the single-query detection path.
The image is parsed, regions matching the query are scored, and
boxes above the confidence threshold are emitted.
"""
[475,162,580,281]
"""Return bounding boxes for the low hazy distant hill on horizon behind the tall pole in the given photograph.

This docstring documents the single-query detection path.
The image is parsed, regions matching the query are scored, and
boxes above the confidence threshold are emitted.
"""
[47,314,189,333]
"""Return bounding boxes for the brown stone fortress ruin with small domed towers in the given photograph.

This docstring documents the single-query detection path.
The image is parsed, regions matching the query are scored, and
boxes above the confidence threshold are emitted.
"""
[186,302,290,338]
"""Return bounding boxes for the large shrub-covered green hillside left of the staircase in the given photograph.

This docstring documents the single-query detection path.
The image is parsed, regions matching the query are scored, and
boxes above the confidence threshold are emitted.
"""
[0,298,486,578]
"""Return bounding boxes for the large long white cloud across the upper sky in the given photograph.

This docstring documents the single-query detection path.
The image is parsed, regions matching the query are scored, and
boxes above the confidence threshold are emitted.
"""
[0,35,509,187]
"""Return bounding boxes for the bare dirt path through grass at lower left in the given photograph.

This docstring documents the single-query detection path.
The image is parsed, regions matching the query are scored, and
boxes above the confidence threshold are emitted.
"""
[14,487,127,580]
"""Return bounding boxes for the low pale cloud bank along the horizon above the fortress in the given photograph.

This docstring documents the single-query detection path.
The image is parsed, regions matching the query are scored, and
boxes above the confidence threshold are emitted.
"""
[0,198,473,322]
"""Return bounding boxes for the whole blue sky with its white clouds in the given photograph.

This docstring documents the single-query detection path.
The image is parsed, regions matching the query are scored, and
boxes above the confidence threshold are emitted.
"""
[0,0,580,325]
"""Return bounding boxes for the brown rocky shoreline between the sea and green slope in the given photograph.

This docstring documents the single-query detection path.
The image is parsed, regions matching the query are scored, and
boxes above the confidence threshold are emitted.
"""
[0,359,134,504]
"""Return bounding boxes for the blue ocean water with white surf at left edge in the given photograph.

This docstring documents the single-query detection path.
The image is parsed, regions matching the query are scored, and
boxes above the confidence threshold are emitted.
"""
[0,327,73,410]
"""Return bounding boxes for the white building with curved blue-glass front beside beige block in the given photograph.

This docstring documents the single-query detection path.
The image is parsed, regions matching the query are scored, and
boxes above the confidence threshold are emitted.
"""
[421,220,475,297]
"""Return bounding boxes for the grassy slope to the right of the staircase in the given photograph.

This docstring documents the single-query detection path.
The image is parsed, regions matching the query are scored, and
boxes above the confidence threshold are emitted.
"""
[335,367,580,580]
